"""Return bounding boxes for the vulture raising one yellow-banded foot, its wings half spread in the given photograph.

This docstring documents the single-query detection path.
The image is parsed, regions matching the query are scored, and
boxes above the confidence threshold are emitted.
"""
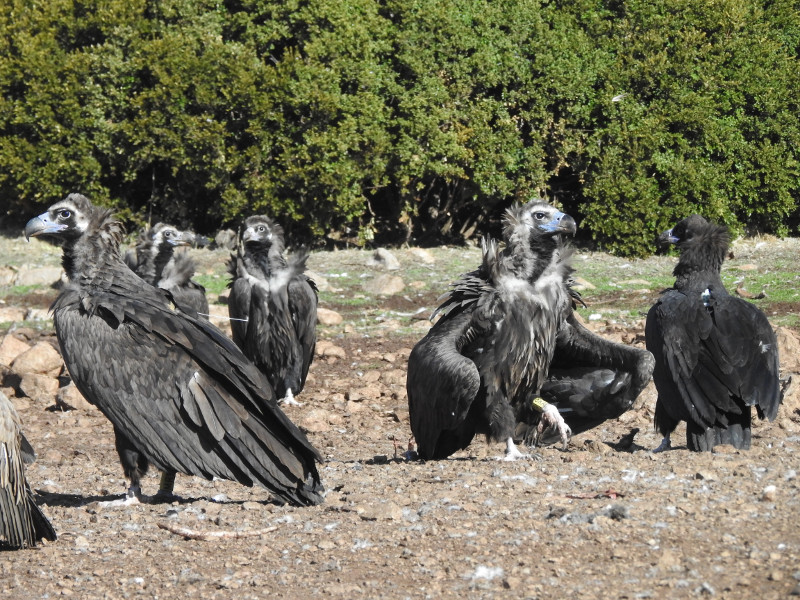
[406,200,653,460]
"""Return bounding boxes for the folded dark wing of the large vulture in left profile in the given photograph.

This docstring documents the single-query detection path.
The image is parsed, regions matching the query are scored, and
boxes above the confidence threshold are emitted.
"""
[53,279,322,505]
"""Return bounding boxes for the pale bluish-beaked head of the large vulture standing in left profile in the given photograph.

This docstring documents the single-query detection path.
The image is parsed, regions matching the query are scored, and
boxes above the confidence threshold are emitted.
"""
[25,194,122,247]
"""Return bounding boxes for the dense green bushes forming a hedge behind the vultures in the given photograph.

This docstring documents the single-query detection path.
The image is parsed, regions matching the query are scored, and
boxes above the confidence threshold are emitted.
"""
[0,0,800,254]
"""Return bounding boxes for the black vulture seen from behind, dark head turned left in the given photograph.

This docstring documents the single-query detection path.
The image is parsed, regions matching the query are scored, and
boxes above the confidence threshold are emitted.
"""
[645,215,781,452]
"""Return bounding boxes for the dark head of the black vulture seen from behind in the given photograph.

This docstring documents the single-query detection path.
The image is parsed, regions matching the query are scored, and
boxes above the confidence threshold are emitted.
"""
[658,215,730,271]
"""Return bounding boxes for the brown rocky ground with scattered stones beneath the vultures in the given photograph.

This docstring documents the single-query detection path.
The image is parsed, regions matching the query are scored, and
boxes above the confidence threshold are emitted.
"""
[0,233,800,599]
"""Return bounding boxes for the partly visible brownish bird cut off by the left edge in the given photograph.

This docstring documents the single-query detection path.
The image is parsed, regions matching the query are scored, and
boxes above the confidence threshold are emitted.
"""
[0,392,56,549]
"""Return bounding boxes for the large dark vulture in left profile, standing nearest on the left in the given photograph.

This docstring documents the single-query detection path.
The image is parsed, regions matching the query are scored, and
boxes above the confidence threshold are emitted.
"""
[25,194,323,505]
